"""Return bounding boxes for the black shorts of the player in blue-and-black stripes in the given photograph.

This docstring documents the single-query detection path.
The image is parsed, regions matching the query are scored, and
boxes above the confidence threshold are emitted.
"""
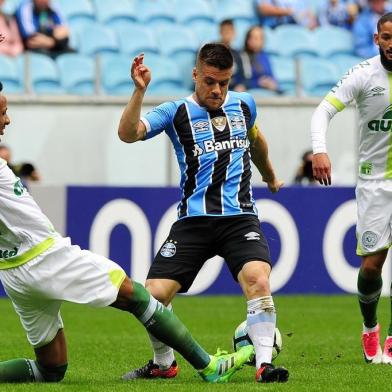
[147,215,271,293]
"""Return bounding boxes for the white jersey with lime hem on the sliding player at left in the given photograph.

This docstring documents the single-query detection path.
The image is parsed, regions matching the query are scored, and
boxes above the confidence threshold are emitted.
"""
[0,159,59,269]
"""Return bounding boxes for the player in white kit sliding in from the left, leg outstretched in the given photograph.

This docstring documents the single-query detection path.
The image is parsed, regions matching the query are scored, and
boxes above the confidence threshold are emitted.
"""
[0,88,253,384]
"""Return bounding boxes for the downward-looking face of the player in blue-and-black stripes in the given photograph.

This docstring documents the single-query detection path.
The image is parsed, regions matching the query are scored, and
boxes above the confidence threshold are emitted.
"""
[193,63,233,110]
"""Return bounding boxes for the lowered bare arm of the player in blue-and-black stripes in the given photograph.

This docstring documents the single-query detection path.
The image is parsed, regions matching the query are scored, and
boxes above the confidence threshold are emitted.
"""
[248,125,283,193]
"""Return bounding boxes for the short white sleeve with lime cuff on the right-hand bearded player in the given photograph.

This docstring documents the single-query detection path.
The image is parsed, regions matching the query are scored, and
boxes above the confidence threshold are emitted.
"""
[325,67,361,112]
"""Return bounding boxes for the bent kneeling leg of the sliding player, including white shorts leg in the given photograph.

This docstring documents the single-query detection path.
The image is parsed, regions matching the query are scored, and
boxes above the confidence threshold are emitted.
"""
[0,266,67,383]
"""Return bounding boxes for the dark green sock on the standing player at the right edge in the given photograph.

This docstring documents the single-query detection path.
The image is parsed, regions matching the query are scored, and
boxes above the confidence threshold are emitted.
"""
[358,269,382,328]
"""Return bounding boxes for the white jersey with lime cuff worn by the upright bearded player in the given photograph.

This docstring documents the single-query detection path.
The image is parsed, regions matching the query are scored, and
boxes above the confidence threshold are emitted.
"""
[325,56,392,180]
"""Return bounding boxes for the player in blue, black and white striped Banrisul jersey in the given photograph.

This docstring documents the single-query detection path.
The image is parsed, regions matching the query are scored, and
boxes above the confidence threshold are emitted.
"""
[118,43,288,382]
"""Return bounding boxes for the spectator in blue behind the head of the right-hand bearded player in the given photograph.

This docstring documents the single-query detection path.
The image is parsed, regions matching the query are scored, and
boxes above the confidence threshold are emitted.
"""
[353,0,392,58]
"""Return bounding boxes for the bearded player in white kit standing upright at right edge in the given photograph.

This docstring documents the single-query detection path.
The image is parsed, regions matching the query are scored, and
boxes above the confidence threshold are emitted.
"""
[311,13,392,364]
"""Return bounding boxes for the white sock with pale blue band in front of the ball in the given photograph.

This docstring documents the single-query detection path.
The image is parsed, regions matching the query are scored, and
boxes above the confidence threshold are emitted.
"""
[246,295,276,369]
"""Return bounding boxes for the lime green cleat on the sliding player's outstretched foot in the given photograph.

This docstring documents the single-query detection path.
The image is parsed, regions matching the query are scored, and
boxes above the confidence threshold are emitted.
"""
[199,345,254,383]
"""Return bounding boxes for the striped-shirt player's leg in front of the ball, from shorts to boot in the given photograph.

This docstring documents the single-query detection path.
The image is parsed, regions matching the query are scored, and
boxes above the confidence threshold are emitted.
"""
[220,216,288,382]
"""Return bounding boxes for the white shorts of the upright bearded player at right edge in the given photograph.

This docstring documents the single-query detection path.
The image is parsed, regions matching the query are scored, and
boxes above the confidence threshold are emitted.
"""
[355,179,392,256]
